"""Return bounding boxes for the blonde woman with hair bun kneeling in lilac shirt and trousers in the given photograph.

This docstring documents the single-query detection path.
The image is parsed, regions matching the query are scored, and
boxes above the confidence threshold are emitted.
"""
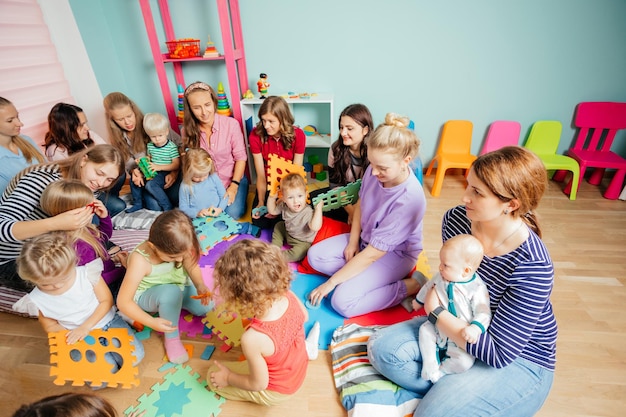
[308,113,426,317]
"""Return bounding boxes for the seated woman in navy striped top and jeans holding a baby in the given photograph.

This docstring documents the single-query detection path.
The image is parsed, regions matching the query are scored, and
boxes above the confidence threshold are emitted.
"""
[368,146,557,417]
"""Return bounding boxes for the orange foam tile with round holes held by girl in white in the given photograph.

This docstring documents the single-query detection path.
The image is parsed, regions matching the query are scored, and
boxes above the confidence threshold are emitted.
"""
[48,329,139,388]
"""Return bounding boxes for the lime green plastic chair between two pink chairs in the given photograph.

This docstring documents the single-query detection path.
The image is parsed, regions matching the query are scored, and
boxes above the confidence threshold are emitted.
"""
[524,120,580,200]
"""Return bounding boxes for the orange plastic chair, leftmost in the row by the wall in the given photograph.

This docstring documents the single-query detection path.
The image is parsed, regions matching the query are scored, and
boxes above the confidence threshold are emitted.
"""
[425,120,476,197]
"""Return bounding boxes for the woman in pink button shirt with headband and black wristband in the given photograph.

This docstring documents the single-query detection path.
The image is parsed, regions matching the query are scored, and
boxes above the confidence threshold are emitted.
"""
[182,81,248,219]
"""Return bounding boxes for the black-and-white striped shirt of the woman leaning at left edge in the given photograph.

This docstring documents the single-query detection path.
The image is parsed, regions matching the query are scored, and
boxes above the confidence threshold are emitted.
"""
[0,164,62,265]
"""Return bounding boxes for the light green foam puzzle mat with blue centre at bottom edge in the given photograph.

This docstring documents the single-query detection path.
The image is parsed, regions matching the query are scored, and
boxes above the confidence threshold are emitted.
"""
[124,365,226,417]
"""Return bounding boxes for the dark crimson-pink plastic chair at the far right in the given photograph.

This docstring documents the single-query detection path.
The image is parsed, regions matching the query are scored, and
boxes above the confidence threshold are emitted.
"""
[553,102,626,200]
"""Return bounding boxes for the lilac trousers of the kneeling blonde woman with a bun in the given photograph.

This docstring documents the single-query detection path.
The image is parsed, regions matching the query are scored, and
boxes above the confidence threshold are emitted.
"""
[307,233,417,317]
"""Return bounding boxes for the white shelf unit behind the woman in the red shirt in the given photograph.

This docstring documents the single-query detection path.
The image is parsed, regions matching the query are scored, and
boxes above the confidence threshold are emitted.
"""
[240,93,337,148]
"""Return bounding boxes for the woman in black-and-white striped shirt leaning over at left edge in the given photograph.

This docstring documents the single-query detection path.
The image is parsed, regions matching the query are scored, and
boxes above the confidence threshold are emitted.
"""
[0,145,124,290]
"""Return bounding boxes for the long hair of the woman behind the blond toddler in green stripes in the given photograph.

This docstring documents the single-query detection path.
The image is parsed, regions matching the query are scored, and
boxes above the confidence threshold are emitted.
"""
[102,92,150,162]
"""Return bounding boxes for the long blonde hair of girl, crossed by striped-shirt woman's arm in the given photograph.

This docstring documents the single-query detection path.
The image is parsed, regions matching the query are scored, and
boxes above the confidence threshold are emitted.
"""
[39,180,108,259]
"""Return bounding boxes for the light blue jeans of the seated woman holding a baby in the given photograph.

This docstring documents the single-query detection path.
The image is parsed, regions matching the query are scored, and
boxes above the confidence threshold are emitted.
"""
[367,317,554,417]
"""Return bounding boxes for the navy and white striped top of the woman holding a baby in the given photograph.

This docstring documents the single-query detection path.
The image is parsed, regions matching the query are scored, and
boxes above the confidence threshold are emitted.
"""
[442,206,557,370]
